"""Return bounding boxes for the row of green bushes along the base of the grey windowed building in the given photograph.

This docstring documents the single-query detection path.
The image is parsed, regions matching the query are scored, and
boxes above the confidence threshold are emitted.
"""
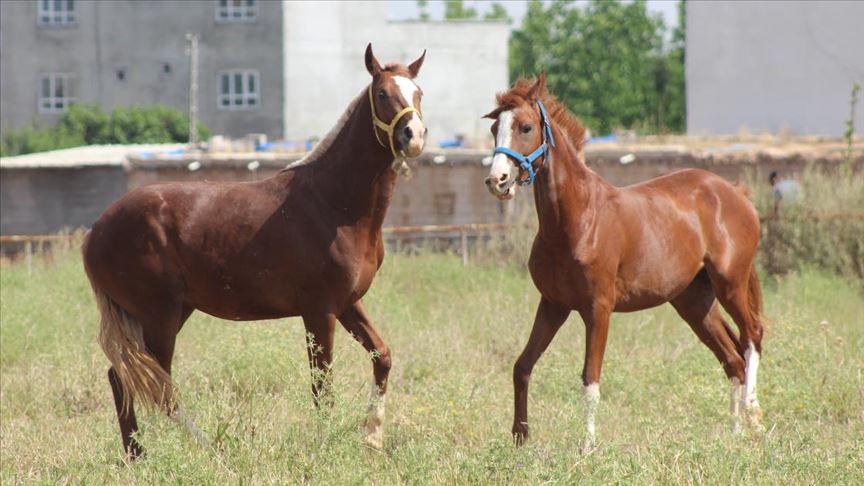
[0,104,210,157]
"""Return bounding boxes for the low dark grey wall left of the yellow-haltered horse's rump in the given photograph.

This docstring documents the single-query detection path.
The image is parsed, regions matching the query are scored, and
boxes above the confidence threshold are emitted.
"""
[0,165,126,235]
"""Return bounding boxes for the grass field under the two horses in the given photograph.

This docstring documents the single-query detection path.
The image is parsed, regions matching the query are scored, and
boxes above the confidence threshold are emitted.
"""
[0,251,864,484]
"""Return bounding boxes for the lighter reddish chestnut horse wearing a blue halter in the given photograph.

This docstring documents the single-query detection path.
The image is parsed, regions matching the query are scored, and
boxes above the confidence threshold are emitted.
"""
[486,75,762,449]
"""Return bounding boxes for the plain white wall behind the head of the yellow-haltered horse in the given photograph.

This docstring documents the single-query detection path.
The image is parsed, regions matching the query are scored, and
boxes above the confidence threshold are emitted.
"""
[283,1,509,145]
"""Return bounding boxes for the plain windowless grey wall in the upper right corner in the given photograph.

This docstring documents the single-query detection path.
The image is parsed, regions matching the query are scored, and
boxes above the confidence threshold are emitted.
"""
[686,0,864,136]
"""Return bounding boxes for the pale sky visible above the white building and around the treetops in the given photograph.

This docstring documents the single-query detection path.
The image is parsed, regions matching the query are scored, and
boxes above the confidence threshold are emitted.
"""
[389,0,678,30]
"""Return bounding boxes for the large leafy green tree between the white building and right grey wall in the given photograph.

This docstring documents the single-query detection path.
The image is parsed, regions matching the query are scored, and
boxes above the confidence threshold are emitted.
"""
[510,0,685,133]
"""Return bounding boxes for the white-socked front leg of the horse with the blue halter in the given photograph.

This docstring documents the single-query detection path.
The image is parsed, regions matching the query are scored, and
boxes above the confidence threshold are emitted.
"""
[579,299,613,453]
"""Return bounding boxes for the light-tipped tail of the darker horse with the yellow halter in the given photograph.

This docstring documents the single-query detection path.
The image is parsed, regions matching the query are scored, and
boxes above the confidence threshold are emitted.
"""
[93,287,174,411]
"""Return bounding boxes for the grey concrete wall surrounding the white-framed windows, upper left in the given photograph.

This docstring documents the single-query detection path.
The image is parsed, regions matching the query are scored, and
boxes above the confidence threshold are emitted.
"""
[0,0,283,137]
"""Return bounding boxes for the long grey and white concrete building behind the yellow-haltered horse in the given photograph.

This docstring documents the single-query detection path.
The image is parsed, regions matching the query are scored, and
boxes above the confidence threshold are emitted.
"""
[0,0,508,143]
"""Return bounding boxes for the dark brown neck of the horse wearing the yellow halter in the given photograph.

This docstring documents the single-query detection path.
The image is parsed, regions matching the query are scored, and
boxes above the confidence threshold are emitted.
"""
[288,90,397,229]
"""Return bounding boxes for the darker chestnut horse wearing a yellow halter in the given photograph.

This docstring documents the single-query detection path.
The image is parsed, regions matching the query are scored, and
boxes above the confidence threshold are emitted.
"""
[83,44,426,458]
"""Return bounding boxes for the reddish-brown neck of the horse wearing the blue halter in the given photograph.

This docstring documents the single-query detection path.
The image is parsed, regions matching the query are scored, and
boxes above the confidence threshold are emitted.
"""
[534,128,608,240]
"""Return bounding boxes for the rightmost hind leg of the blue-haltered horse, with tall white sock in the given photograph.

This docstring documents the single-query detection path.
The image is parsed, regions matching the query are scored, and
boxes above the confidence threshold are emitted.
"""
[708,263,762,427]
